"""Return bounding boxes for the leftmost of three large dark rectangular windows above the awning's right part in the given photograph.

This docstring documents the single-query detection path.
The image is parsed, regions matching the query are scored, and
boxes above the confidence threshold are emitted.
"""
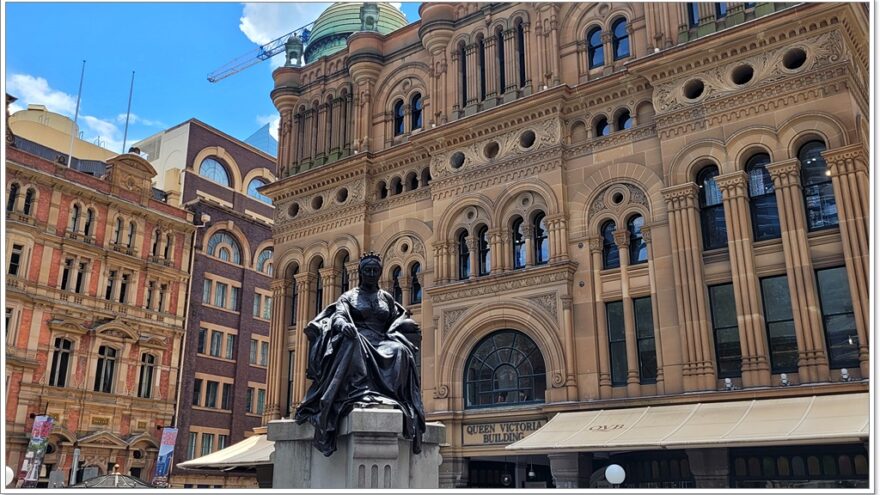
[709,284,742,378]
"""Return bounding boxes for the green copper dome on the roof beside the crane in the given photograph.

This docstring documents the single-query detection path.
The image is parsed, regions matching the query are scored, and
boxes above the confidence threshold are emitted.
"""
[305,2,407,64]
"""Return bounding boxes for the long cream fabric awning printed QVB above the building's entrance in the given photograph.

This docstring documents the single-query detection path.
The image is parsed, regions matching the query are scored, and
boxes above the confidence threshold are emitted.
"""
[507,393,870,453]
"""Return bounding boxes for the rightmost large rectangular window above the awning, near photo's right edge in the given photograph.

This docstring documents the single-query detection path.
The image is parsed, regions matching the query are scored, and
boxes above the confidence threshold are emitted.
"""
[816,266,859,369]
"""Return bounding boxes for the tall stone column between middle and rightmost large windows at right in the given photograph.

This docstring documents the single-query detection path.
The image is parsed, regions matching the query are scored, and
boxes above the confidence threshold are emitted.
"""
[767,158,830,383]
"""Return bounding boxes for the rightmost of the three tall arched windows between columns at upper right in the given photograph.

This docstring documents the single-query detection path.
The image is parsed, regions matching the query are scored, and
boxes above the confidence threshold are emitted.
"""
[798,141,837,230]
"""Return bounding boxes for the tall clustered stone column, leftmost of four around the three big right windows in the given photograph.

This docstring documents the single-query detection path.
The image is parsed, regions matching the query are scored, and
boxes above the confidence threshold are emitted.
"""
[661,182,715,391]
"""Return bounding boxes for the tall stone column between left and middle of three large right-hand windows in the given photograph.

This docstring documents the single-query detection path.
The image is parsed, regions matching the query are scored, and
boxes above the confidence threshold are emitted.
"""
[715,170,770,387]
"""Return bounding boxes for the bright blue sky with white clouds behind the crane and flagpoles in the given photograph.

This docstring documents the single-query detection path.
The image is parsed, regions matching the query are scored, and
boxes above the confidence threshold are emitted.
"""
[3,2,419,151]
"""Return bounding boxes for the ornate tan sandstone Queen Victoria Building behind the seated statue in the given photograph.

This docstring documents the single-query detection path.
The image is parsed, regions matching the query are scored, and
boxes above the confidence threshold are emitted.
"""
[263,3,870,487]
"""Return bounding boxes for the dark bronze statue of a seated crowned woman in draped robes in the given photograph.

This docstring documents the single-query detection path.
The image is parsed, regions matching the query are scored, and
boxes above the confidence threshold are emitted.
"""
[295,253,425,457]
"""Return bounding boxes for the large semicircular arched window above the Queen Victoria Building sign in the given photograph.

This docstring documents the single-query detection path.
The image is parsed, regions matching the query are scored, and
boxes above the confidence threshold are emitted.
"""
[464,330,547,409]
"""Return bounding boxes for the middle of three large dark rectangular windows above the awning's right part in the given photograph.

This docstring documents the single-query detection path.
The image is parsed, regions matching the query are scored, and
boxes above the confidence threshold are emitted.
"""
[761,275,798,373]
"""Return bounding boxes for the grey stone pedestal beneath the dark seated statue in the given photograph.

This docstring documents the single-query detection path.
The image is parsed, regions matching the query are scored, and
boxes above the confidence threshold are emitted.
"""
[267,409,446,489]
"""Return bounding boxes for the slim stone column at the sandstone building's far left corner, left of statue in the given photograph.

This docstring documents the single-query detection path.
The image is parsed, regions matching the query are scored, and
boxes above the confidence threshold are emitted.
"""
[263,279,288,425]
